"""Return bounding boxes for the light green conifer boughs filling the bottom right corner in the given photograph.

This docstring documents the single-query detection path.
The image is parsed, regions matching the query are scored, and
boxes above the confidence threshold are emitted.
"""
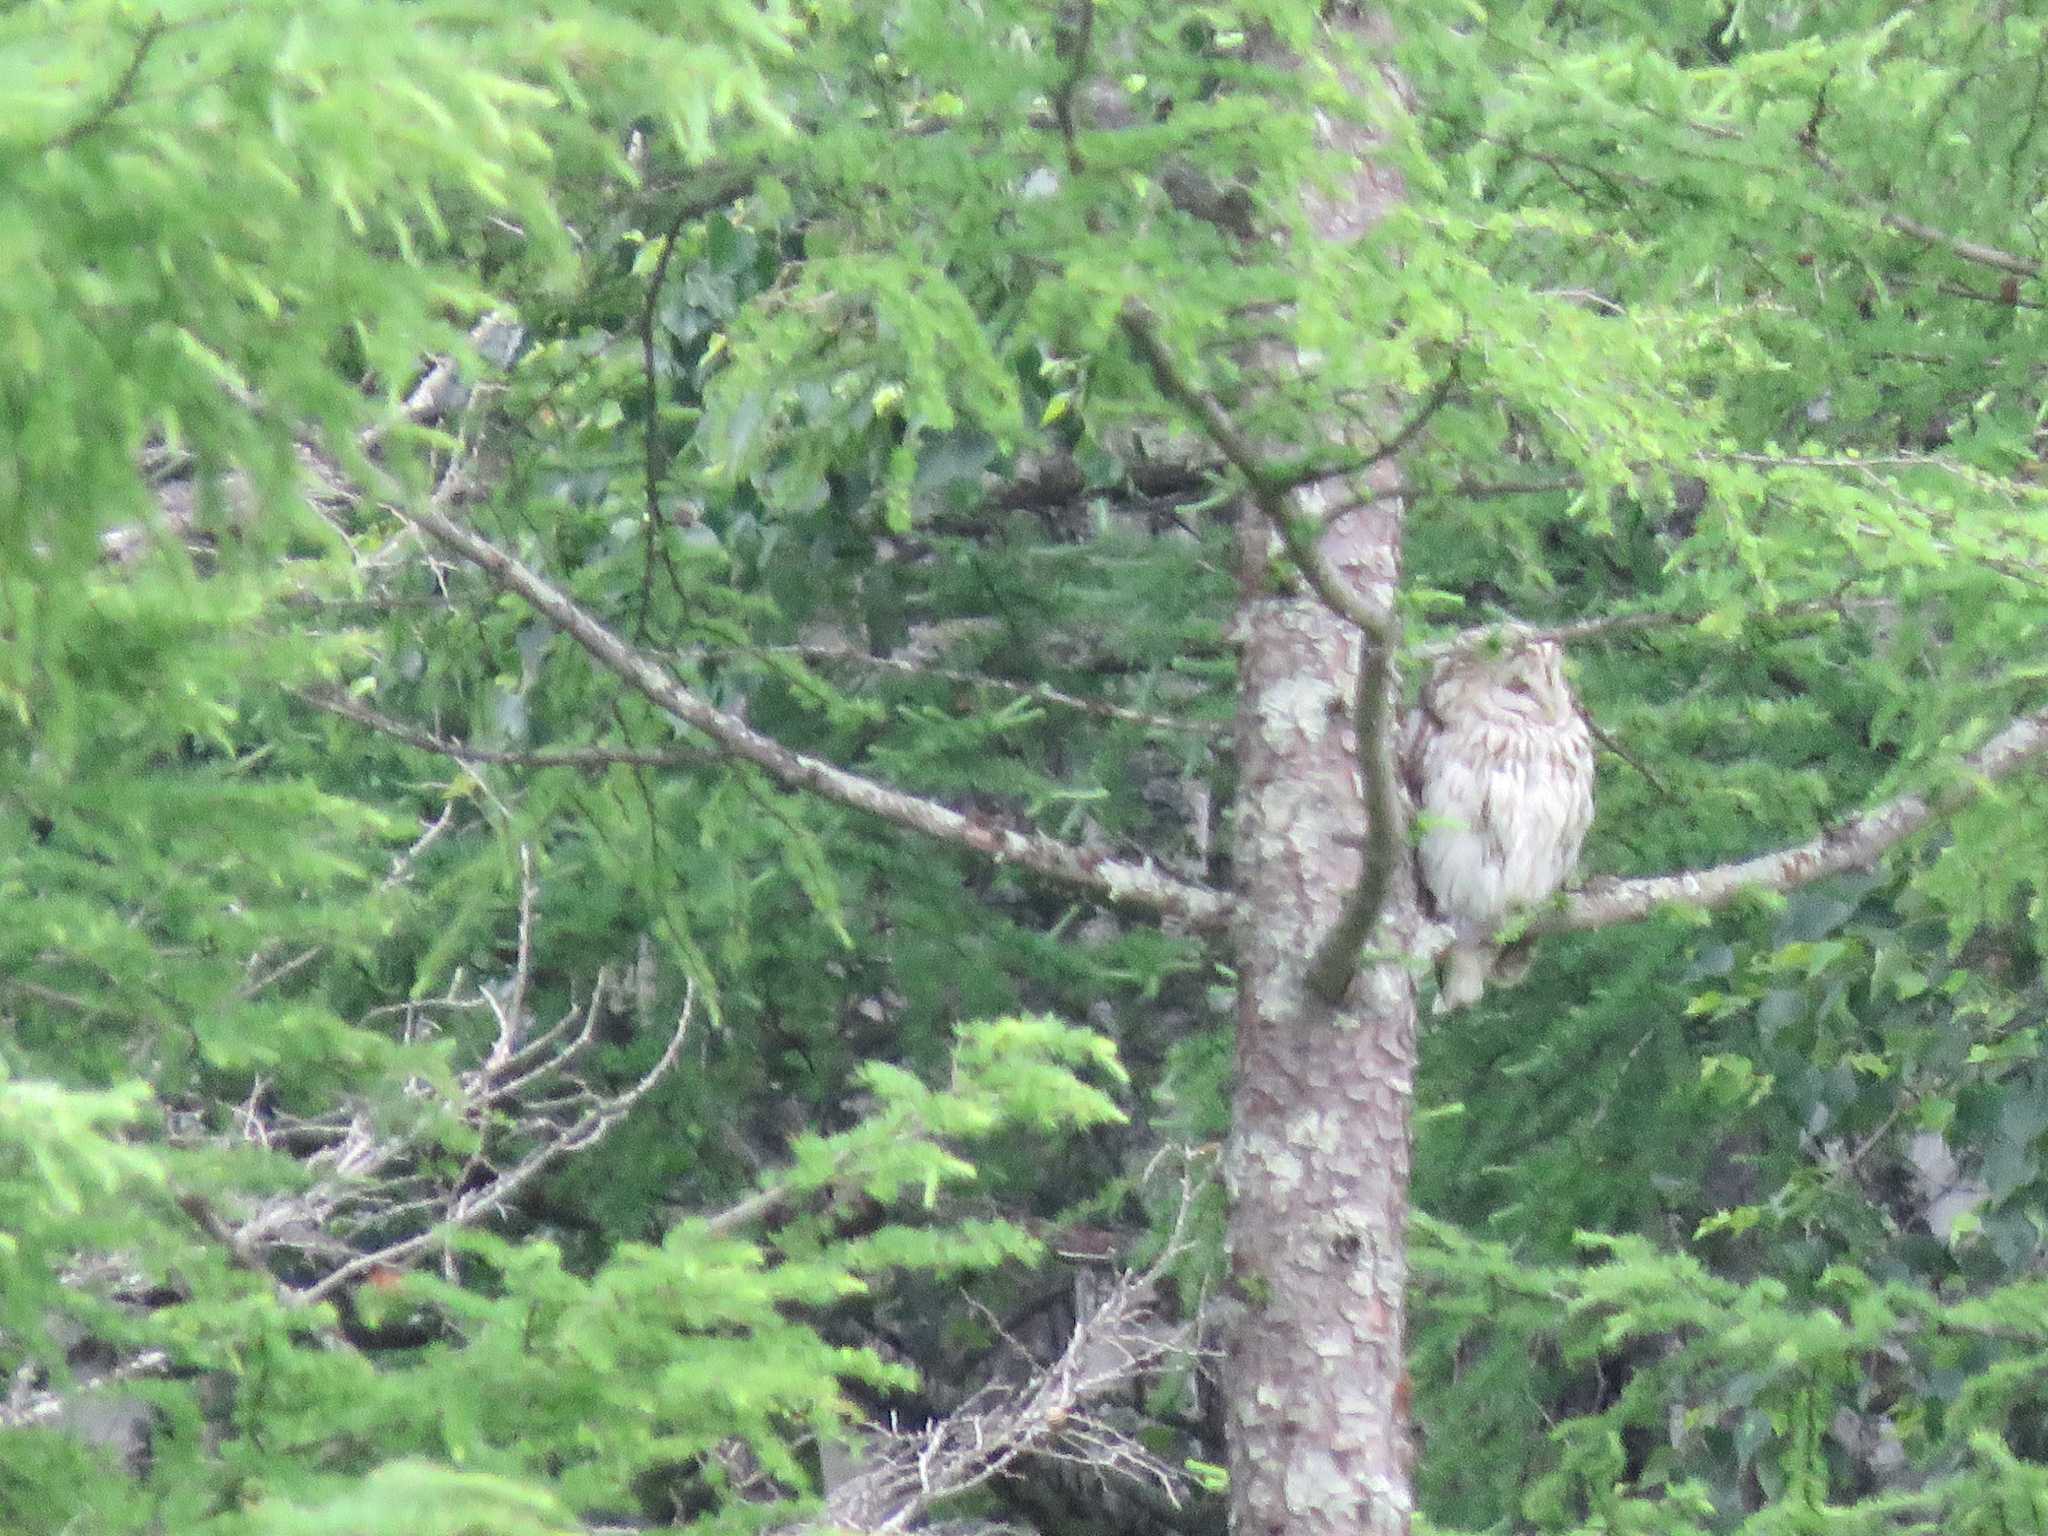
[1417,1225,2048,1536]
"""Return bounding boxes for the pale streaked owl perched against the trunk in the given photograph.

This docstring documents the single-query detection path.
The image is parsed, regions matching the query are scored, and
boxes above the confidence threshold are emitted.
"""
[1403,641,1593,1014]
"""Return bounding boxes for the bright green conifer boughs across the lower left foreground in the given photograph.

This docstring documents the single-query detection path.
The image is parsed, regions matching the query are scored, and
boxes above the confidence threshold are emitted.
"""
[0,1018,1120,1532]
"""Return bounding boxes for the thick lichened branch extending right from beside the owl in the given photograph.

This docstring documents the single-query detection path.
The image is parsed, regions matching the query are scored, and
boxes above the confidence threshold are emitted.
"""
[1526,711,2048,934]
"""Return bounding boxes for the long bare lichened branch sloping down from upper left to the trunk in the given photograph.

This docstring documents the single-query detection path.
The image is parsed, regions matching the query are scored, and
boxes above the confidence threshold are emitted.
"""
[395,506,1229,930]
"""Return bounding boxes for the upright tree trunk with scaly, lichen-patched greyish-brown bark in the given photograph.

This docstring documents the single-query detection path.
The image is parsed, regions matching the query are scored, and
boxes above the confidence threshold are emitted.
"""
[1225,15,1417,1536]
